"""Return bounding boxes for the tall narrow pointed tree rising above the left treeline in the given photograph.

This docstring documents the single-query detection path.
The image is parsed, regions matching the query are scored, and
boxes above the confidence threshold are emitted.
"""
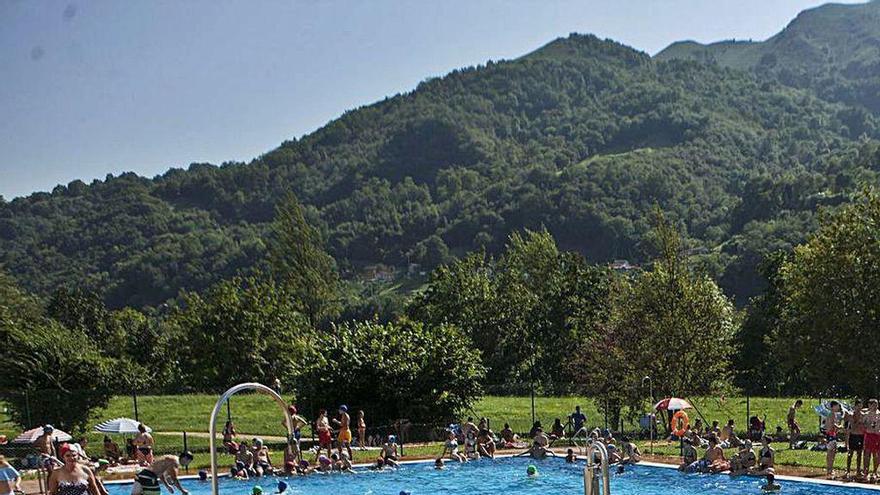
[270,193,340,327]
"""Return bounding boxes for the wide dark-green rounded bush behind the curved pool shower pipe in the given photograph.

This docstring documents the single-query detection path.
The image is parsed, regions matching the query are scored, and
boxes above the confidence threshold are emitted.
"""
[297,318,485,424]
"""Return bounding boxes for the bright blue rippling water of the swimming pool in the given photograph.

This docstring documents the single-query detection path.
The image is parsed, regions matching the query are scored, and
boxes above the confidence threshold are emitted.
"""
[107,458,880,495]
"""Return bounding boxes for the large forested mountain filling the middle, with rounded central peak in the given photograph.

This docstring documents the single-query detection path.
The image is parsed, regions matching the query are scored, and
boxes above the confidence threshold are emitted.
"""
[0,28,880,307]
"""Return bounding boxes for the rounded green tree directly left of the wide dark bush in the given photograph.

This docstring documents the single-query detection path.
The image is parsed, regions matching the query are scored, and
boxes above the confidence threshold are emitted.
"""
[166,277,311,391]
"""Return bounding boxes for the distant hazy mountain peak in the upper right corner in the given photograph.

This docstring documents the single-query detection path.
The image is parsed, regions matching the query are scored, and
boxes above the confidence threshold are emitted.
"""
[656,0,880,115]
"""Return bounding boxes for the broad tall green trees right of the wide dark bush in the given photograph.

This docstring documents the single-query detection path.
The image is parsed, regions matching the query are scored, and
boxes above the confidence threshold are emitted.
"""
[409,231,610,393]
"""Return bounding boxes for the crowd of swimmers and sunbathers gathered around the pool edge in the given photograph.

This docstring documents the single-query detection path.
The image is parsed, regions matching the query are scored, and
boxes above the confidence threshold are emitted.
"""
[18,399,880,495]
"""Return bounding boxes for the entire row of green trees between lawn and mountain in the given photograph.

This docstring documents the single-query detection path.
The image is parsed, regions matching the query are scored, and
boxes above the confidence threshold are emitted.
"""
[0,192,880,428]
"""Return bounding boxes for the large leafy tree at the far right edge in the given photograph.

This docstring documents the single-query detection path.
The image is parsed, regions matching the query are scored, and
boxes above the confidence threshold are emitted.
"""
[773,191,880,397]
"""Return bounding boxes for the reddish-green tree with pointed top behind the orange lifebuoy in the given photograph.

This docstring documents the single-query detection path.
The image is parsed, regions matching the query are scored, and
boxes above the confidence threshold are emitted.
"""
[598,212,737,404]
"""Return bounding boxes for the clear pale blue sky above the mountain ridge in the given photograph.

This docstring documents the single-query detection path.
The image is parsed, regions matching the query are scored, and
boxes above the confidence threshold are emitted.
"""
[0,0,868,199]
